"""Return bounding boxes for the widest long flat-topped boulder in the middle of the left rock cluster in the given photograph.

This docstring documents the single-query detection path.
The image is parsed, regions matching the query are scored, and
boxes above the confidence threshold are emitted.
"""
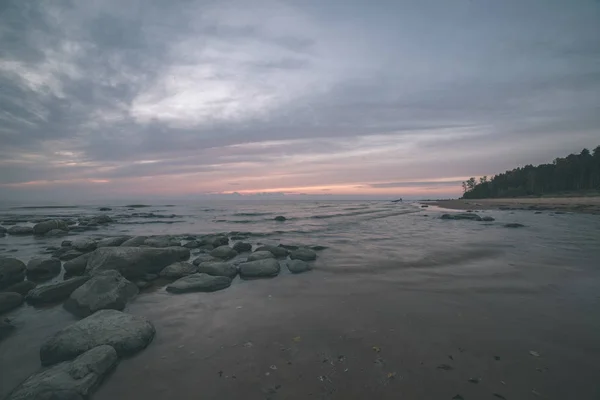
[86,246,190,279]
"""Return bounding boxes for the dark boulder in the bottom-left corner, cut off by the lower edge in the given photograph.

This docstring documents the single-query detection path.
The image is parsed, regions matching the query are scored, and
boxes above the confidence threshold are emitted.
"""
[7,345,119,400]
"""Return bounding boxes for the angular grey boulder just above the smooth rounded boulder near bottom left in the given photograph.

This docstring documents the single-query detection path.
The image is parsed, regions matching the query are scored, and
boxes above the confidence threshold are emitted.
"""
[64,270,138,317]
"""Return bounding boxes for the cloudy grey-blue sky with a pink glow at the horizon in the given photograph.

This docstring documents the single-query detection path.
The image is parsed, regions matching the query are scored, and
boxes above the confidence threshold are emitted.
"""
[0,0,600,201]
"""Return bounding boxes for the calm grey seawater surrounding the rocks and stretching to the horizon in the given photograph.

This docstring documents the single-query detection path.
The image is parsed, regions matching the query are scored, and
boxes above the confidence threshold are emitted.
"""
[0,201,600,399]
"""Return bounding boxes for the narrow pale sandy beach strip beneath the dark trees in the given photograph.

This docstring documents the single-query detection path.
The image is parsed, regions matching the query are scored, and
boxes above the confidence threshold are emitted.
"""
[422,196,600,215]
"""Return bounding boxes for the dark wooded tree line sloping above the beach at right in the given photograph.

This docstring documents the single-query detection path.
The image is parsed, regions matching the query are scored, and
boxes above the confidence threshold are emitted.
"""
[462,146,600,199]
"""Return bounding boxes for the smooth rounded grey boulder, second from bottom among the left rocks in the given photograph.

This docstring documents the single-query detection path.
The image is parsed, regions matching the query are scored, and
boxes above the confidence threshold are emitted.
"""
[40,310,156,365]
